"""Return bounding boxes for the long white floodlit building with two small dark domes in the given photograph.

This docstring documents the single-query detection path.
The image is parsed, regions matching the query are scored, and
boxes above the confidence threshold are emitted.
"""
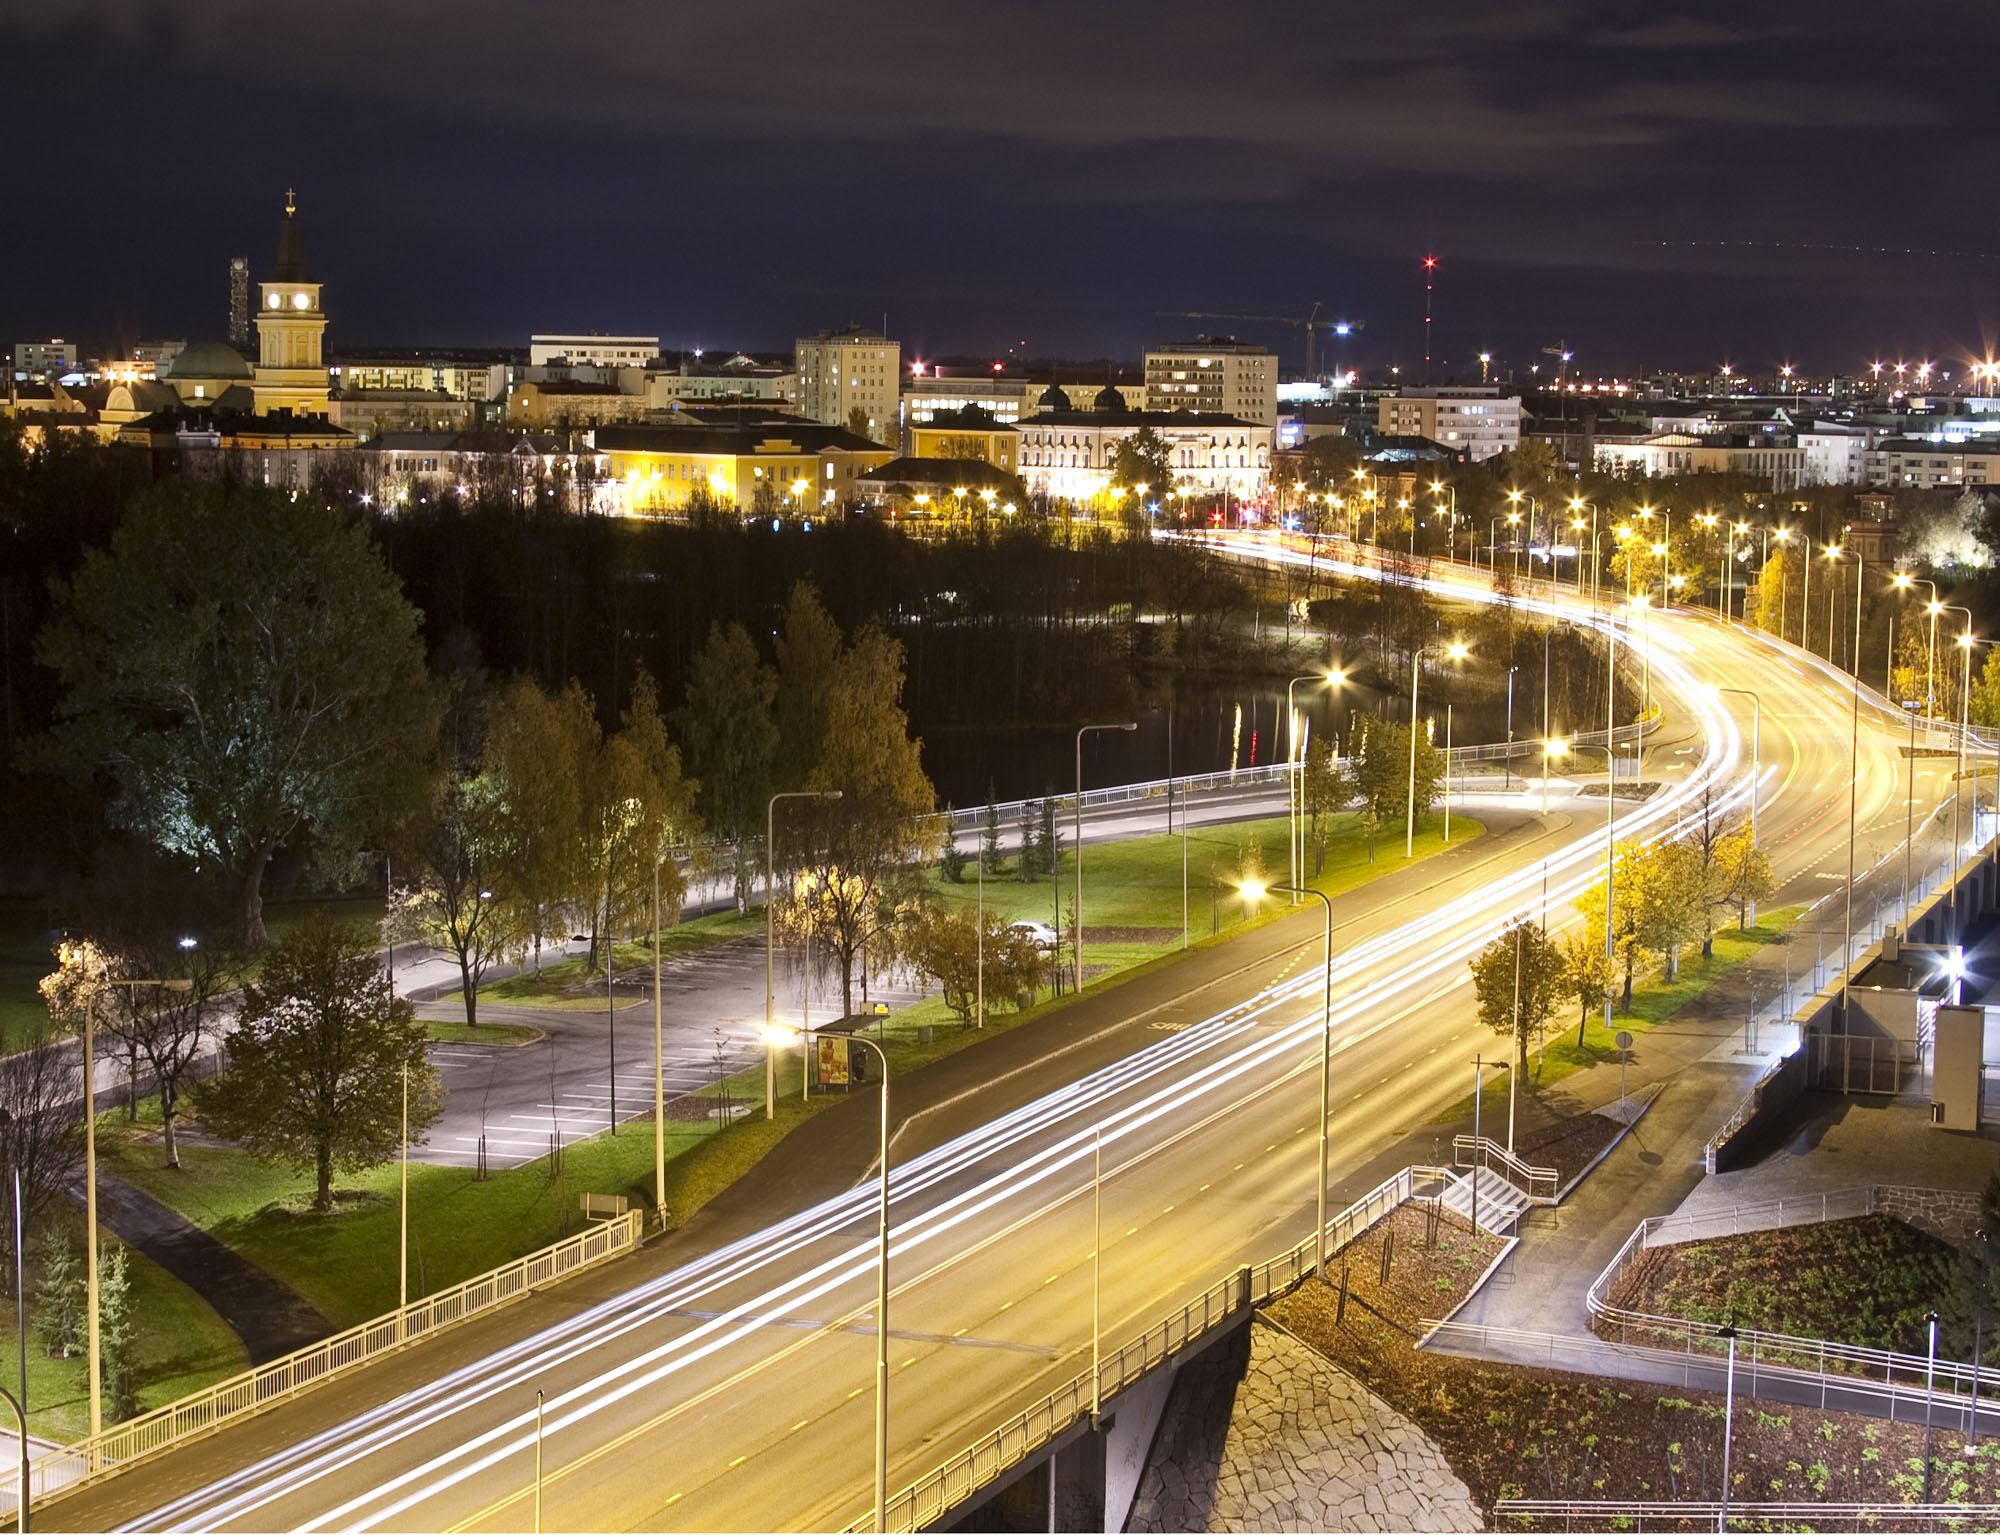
[1016,386,1272,502]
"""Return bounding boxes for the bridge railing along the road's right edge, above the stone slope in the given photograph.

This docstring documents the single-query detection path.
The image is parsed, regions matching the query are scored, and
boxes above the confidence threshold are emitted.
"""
[846,1167,1452,1533]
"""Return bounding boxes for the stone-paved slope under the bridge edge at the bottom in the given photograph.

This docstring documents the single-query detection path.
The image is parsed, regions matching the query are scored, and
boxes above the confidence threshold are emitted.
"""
[1126,1319,1484,1531]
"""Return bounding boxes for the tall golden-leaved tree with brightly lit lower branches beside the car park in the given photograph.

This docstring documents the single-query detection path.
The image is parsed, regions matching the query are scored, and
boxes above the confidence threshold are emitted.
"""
[788,628,936,1017]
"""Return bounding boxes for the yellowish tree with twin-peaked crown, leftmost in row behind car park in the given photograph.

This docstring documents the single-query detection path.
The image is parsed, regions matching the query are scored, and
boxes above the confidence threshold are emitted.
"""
[486,678,600,971]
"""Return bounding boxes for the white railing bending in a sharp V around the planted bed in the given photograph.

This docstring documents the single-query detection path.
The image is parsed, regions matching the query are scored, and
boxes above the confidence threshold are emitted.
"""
[1584,1215,2000,1413]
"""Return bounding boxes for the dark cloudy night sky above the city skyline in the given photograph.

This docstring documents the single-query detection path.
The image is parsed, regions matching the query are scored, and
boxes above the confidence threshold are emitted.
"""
[15,0,2000,372]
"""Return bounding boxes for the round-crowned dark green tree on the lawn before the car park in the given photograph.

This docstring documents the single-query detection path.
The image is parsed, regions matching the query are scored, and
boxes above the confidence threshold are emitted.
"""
[196,915,444,1211]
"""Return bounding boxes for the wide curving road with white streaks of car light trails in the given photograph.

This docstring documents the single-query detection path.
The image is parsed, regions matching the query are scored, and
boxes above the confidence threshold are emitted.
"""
[40,551,1970,1529]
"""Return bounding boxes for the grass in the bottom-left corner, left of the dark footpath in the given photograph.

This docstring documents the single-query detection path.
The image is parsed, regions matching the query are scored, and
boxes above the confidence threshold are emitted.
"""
[0,1231,250,1439]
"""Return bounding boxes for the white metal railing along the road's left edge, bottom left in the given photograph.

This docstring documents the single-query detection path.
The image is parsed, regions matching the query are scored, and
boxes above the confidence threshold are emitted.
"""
[27,1209,642,1507]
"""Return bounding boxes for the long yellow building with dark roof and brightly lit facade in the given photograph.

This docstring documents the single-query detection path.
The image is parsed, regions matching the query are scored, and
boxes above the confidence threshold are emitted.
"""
[590,420,894,516]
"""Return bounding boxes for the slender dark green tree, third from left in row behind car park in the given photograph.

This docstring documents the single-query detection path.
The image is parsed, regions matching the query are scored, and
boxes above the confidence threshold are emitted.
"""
[674,624,778,911]
